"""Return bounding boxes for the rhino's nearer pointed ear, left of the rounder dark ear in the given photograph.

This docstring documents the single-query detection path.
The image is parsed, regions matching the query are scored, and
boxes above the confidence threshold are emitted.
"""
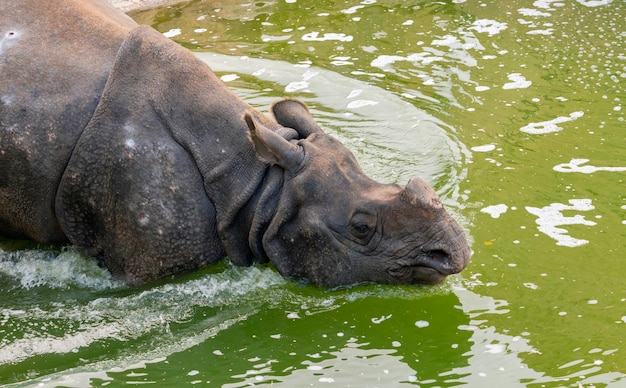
[244,113,304,170]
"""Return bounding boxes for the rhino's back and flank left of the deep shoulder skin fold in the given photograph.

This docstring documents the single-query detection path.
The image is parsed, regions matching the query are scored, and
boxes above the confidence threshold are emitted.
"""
[0,0,136,241]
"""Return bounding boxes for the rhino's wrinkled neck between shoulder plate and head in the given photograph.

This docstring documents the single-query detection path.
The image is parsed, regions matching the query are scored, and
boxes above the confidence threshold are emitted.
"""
[112,27,282,265]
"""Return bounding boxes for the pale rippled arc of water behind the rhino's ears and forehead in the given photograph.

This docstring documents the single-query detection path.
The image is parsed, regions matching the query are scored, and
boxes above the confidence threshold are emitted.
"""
[197,52,469,202]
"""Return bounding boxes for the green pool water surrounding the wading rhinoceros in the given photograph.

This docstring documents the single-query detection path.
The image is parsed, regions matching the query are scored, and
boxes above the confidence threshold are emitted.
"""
[0,0,626,387]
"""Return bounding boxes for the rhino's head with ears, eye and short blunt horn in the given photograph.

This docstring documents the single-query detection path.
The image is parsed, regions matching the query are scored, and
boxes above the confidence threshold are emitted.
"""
[245,100,470,286]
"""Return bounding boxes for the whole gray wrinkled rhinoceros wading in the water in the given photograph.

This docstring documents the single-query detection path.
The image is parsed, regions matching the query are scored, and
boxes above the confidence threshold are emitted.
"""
[0,0,470,286]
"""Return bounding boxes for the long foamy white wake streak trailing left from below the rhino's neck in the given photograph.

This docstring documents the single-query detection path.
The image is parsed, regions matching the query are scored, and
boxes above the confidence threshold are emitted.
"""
[0,267,286,365]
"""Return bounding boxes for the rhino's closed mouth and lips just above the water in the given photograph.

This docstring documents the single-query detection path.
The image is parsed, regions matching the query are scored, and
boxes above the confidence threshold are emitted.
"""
[387,250,458,284]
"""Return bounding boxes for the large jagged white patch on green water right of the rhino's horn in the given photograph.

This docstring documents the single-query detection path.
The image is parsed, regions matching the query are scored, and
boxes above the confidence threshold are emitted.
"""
[526,199,596,248]
